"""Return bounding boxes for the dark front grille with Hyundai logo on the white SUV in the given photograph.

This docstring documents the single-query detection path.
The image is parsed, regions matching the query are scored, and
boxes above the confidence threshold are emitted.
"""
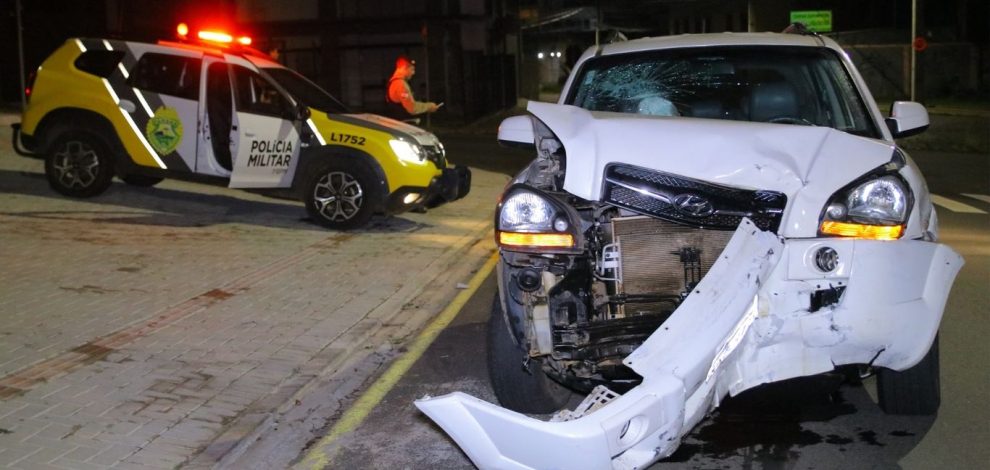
[602,165,787,233]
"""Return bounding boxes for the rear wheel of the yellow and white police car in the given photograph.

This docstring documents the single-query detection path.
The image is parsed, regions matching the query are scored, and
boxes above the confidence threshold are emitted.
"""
[45,132,113,197]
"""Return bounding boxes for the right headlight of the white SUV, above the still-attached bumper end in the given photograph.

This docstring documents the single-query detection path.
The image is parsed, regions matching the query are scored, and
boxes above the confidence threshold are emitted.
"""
[818,173,912,240]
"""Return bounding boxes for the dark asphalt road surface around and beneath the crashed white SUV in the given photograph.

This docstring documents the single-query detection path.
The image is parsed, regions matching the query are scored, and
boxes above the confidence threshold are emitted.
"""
[302,139,990,469]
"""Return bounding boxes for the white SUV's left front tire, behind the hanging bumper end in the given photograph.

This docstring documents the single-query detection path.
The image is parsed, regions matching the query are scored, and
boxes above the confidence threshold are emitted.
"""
[488,294,574,414]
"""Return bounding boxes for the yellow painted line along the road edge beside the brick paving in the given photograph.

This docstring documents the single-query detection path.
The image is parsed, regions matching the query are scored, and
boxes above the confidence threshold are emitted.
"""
[296,254,498,470]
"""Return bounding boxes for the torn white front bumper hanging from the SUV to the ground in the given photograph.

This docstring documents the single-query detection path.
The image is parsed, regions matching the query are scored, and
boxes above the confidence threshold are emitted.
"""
[416,220,962,469]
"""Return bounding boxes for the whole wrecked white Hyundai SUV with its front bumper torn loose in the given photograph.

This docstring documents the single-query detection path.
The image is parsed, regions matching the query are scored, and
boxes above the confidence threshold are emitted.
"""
[416,33,963,469]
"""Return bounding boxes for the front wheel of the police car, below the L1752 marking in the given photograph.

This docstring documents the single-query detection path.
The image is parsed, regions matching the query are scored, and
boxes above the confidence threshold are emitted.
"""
[304,162,380,230]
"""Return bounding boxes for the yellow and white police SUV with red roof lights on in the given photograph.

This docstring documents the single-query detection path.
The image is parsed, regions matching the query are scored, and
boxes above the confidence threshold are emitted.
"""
[14,25,471,230]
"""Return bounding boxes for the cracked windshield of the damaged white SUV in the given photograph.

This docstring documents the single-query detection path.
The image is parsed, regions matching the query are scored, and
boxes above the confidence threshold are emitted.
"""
[568,46,879,137]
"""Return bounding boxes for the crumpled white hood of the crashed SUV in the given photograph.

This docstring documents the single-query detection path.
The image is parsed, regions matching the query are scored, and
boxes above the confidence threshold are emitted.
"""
[528,102,894,236]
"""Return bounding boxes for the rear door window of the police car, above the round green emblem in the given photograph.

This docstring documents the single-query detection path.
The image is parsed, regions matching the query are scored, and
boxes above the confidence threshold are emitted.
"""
[128,52,201,100]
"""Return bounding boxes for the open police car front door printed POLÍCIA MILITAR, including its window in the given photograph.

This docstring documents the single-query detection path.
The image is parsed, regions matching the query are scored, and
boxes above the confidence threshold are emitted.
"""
[230,57,301,188]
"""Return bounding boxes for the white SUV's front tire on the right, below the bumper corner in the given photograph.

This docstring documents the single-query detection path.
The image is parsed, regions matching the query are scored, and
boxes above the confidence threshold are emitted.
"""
[877,335,942,415]
